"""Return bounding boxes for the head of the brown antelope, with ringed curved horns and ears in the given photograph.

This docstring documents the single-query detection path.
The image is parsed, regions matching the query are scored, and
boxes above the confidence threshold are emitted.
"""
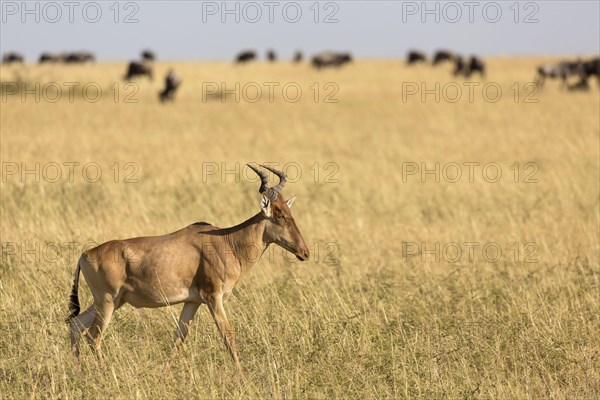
[248,164,310,261]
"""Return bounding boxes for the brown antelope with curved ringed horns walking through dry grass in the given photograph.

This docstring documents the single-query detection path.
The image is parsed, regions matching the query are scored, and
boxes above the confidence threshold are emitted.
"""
[67,165,309,372]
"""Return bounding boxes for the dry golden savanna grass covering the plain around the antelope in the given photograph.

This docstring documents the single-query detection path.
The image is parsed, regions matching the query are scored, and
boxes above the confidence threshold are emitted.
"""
[0,58,600,399]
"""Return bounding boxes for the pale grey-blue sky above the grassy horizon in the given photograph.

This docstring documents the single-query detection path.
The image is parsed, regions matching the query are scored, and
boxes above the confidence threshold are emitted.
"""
[0,0,600,61]
